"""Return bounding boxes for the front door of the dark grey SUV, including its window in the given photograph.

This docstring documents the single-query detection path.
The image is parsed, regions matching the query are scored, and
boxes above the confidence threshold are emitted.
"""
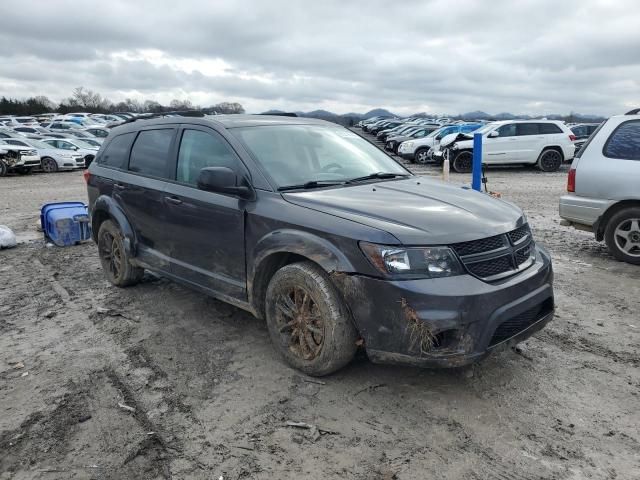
[164,125,246,300]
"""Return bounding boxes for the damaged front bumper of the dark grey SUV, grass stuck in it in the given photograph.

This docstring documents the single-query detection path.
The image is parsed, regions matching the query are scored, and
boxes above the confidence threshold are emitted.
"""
[334,247,554,367]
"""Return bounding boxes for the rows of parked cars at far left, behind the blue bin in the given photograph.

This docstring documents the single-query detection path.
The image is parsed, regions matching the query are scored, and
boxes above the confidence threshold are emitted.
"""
[0,112,139,176]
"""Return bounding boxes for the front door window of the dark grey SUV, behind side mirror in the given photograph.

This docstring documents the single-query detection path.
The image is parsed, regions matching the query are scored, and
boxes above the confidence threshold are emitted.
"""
[176,130,238,186]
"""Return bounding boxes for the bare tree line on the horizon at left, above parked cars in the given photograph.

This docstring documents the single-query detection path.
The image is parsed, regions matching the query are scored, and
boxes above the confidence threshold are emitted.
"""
[0,87,244,116]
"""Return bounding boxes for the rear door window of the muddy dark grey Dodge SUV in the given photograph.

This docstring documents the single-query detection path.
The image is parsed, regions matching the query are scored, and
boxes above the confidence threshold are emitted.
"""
[129,128,174,177]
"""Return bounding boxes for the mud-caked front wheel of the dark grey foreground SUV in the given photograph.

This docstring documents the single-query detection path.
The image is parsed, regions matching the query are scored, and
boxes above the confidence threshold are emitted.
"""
[265,262,358,376]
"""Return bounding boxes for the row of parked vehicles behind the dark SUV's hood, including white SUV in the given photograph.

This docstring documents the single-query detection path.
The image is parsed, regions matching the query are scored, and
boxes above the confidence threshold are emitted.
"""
[358,117,598,173]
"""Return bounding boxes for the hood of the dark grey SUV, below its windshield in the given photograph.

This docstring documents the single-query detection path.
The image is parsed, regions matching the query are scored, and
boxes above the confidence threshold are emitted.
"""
[283,177,526,245]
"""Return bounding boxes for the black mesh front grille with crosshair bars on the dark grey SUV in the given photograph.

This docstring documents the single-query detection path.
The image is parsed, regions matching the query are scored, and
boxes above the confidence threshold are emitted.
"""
[451,225,535,281]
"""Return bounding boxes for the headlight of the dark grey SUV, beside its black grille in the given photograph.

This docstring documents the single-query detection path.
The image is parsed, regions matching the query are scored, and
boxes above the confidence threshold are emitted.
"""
[360,242,463,278]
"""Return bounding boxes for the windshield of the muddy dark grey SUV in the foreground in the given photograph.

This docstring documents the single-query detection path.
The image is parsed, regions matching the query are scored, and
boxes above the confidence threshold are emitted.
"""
[231,125,409,187]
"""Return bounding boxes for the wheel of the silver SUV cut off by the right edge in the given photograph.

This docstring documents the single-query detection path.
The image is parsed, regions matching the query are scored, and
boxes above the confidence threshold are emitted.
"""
[604,207,640,265]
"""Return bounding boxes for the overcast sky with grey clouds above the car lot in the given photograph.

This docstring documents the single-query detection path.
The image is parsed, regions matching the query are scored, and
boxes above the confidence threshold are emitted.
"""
[0,0,640,115]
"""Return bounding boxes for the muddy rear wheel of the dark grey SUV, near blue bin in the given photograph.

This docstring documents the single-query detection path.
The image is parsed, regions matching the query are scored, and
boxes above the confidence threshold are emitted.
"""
[98,220,144,287]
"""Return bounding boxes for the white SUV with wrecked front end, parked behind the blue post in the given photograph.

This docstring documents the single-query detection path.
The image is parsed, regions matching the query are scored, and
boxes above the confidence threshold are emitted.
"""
[444,120,576,173]
